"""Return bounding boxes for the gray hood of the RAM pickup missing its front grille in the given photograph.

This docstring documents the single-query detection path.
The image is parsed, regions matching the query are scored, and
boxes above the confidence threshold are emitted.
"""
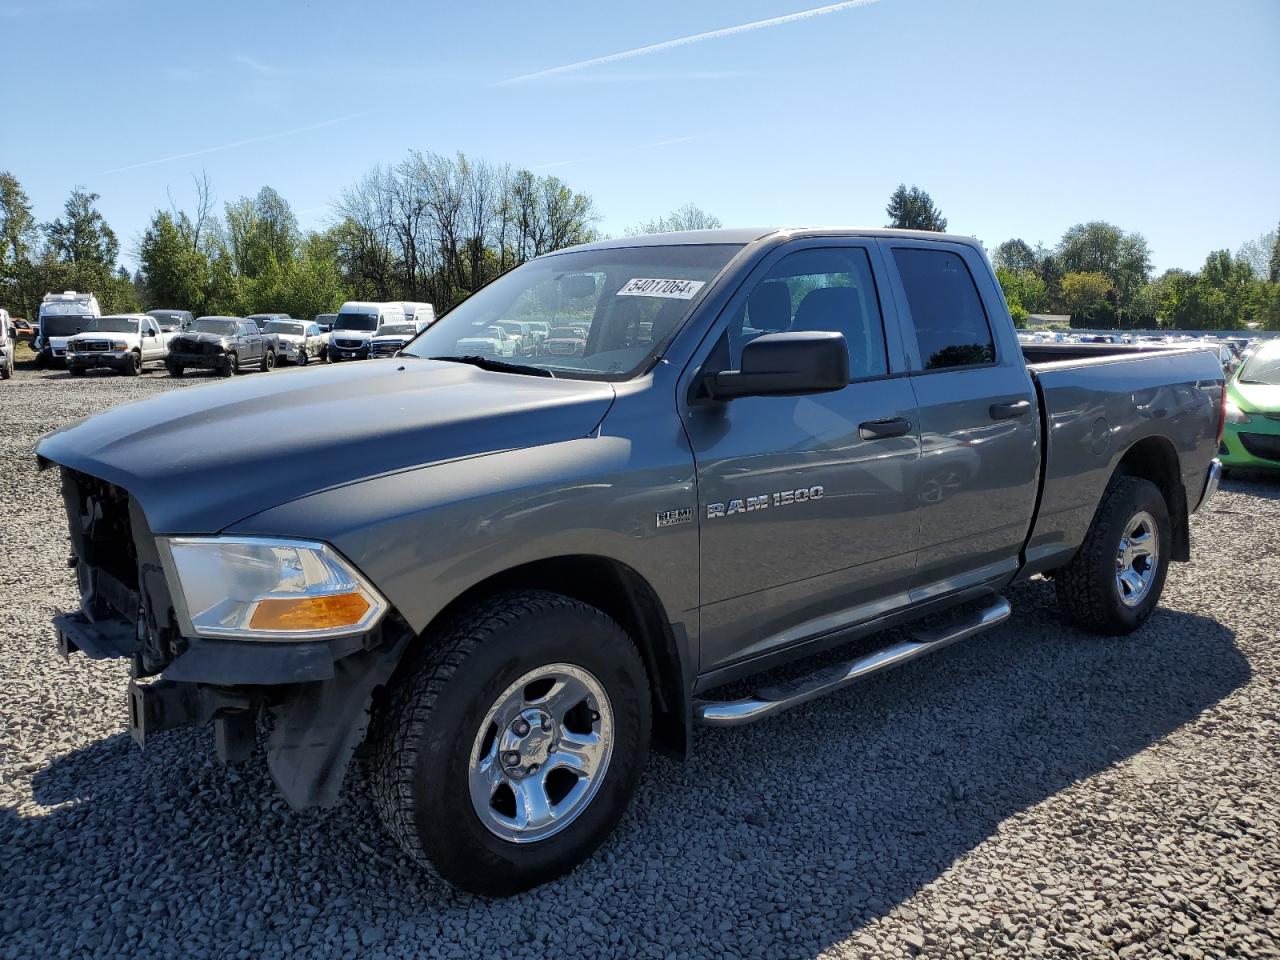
[36,360,613,534]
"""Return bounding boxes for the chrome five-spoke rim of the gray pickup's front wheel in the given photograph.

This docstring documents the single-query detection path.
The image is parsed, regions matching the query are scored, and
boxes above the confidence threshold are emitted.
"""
[468,663,613,844]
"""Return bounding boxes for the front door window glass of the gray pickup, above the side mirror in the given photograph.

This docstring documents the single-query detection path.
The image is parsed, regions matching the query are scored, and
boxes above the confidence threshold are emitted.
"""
[712,247,888,380]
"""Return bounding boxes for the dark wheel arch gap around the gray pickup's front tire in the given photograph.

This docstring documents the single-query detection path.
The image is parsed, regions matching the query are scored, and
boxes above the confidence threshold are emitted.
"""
[389,554,696,758]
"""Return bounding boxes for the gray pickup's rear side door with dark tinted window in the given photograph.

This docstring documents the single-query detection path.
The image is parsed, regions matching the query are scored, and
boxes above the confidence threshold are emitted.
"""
[881,239,1041,603]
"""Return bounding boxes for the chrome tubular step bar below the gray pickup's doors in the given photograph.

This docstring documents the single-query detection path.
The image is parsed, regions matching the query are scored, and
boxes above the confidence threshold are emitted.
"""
[694,596,1012,727]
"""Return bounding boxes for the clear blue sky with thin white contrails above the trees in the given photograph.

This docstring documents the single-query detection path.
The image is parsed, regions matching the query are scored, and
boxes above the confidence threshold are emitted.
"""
[0,0,1280,269]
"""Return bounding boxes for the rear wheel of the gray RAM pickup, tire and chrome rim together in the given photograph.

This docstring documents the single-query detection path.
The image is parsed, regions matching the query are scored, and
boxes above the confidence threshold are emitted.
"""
[1053,476,1172,636]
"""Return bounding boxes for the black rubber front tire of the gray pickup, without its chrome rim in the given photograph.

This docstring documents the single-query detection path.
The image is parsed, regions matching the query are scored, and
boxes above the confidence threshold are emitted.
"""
[370,591,650,896]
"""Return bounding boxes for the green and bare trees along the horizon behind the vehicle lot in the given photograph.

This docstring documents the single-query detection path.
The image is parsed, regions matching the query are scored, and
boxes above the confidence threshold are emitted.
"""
[0,171,1280,330]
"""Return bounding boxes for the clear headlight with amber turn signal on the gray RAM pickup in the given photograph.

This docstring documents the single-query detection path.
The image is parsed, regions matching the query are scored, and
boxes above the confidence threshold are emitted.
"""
[159,536,388,640]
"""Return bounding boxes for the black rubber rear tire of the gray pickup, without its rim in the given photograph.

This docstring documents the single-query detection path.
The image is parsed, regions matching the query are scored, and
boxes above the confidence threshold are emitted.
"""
[1053,476,1172,636]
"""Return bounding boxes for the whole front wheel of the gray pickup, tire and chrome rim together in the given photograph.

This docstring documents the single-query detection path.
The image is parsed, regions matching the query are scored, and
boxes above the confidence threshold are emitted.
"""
[371,591,650,896]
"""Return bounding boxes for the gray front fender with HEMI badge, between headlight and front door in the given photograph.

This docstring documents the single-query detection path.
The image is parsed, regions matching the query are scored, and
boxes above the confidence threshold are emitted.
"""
[228,435,698,647]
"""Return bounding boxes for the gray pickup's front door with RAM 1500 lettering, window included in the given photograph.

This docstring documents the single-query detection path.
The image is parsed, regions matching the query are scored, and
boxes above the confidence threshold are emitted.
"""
[685,239,919,672]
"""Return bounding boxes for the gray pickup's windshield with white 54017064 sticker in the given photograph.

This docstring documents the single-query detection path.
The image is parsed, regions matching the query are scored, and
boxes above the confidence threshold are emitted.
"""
[403,243,741,380]
